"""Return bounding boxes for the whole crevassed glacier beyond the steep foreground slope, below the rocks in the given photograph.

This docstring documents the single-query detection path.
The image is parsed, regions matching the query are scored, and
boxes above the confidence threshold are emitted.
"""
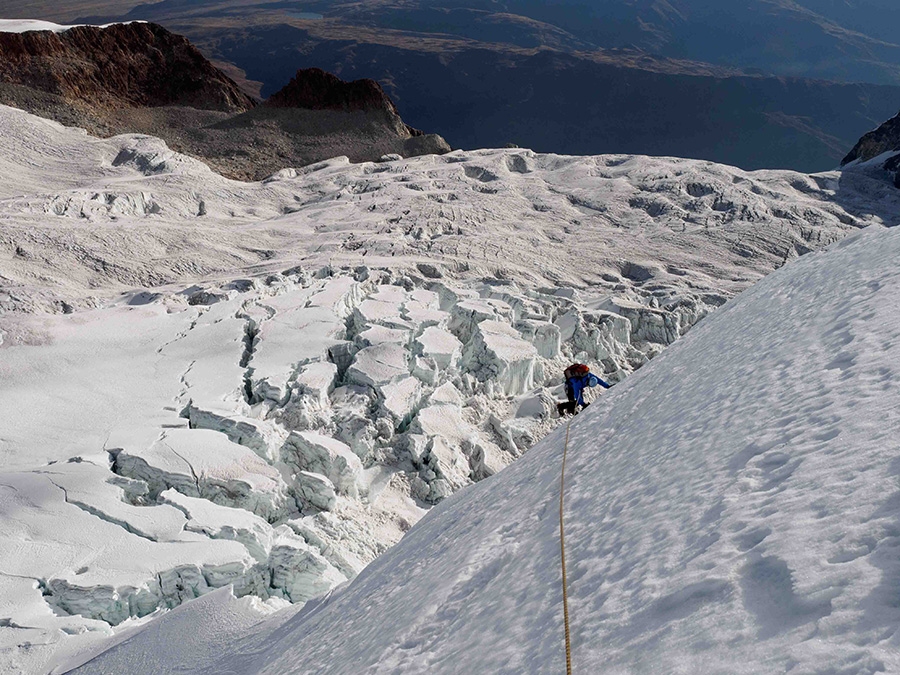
[0,107,900,672]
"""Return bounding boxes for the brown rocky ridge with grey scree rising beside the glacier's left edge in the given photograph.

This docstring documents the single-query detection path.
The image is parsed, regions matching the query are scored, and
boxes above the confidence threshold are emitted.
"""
[0,22,450,180]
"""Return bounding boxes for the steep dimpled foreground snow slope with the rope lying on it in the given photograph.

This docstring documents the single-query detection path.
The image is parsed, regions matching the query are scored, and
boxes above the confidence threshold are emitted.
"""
[67,224,900,675]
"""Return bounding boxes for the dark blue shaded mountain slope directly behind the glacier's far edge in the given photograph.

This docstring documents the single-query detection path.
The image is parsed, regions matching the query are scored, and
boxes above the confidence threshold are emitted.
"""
[185,22,900,172]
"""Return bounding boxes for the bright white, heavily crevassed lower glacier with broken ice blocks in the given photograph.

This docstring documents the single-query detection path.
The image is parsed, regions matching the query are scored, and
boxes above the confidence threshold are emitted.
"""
[0,268,703,670]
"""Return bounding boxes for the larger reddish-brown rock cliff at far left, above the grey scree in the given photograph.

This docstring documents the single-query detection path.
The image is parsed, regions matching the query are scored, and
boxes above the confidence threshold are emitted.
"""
[0,23,255,112]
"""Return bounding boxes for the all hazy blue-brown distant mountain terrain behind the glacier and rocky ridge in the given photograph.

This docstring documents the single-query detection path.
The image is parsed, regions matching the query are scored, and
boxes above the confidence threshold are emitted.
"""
[5,0,900,171]
